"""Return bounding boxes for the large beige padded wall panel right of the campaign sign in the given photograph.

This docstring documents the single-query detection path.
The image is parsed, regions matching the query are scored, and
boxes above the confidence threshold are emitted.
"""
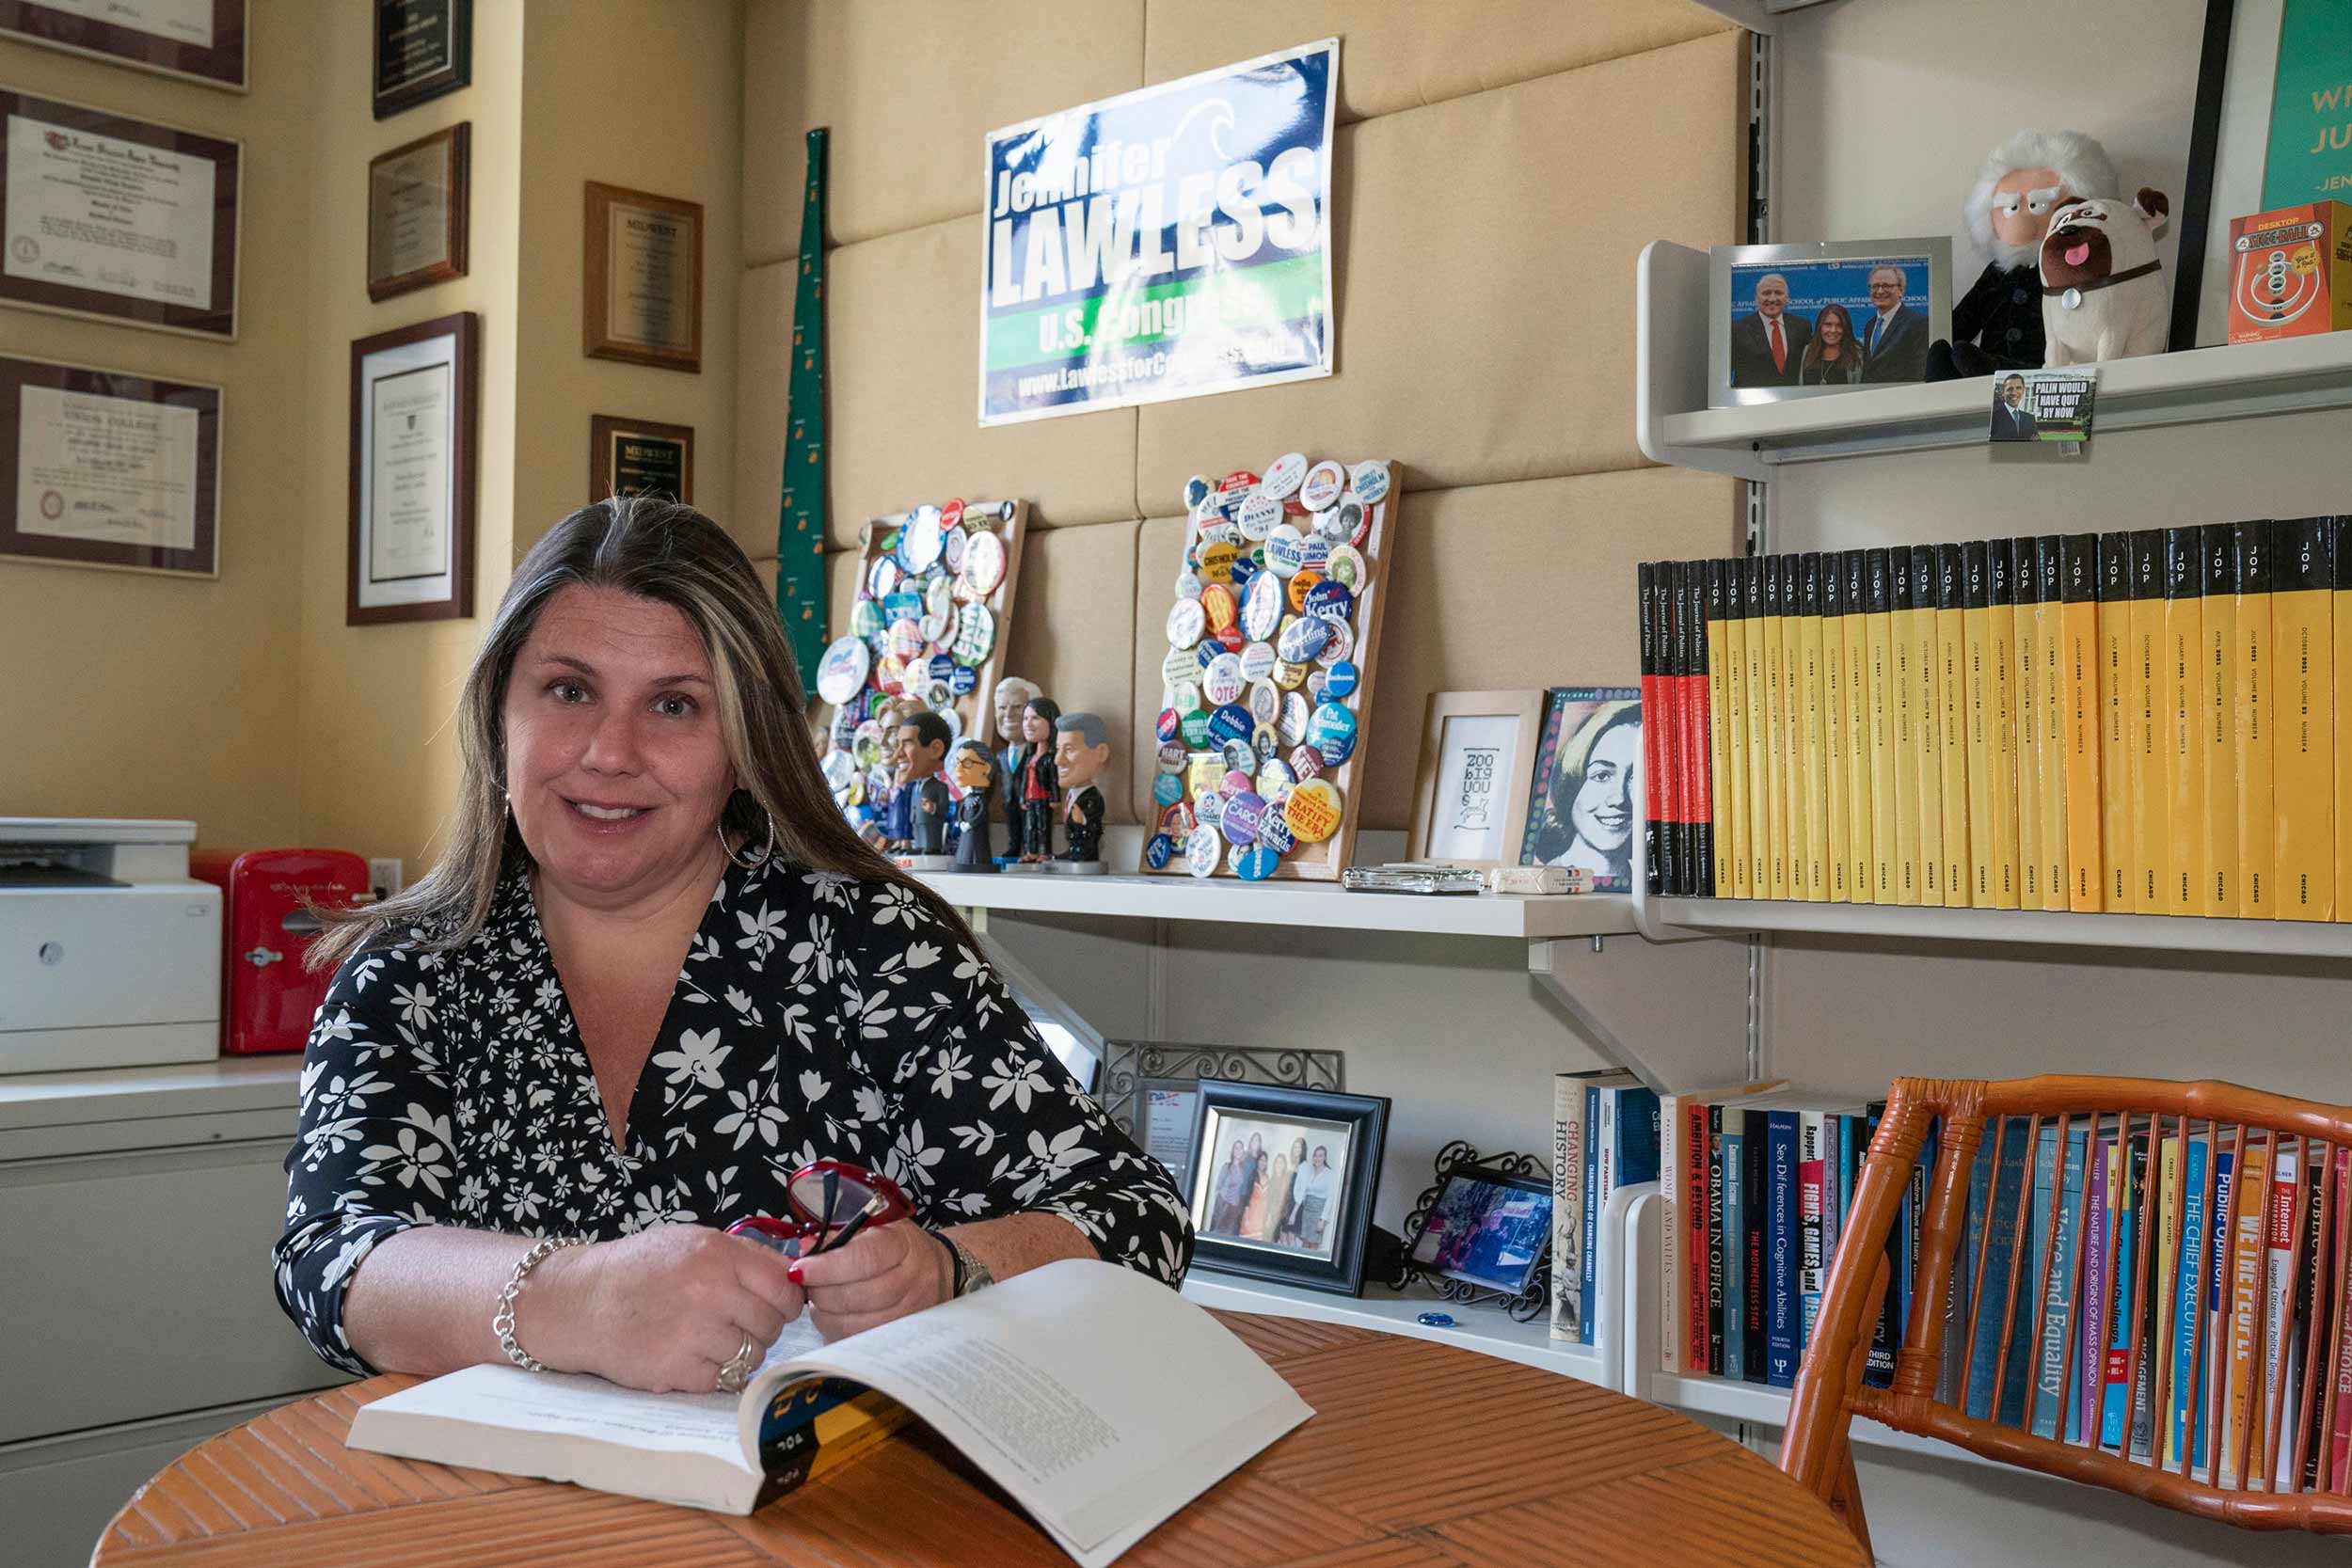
[1136,33,1745,513]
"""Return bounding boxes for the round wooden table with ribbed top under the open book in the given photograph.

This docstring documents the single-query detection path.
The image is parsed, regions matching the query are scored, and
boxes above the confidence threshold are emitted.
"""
[92,1314,1867,1568]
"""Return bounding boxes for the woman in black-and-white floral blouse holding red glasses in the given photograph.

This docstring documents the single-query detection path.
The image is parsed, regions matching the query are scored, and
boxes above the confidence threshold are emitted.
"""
[276,499,1193,1389]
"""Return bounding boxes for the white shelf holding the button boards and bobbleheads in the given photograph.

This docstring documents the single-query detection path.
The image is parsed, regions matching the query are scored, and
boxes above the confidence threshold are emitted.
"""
[915,872,1635,942]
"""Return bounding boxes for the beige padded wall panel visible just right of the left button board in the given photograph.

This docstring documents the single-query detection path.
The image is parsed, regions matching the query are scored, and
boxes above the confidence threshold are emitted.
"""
[997,522,1151,823]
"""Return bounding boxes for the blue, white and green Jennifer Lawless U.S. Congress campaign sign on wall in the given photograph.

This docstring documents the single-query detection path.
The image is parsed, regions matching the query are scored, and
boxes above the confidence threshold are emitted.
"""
[981,38,1339,425]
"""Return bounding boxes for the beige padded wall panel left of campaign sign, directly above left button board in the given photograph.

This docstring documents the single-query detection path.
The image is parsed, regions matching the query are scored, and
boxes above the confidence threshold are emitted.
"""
[833,215,1136,547]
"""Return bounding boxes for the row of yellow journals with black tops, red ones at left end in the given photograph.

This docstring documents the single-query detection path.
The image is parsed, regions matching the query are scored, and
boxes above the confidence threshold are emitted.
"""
[1640,517,2352,922]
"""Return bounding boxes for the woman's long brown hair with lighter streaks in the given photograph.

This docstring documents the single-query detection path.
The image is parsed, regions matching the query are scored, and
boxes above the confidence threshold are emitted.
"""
[309,496,974,969]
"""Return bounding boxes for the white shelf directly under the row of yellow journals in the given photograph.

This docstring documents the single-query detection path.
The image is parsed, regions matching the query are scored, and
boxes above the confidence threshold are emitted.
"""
[1649,898,2352,959]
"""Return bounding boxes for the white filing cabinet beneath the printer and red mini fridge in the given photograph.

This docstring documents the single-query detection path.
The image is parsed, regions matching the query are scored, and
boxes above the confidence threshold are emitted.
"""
[0,1055,342,1568]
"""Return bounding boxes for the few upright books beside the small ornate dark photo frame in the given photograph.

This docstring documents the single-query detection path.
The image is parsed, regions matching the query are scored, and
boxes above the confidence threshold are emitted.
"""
[1552,1069,1659,1345]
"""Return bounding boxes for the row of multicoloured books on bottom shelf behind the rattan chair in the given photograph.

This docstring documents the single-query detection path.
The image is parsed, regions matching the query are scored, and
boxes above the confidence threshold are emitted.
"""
[1661,1086,2352,1493]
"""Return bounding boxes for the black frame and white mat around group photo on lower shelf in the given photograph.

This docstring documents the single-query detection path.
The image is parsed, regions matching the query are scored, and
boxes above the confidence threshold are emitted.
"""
[1185,1079,1388,1295]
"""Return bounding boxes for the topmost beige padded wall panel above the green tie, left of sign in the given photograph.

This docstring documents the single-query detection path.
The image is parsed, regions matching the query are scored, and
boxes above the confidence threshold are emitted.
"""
[743,0,1138,262]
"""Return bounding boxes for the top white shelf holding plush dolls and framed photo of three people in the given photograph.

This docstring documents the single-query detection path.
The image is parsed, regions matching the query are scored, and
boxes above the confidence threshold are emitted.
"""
[1635,240,2352,480]
